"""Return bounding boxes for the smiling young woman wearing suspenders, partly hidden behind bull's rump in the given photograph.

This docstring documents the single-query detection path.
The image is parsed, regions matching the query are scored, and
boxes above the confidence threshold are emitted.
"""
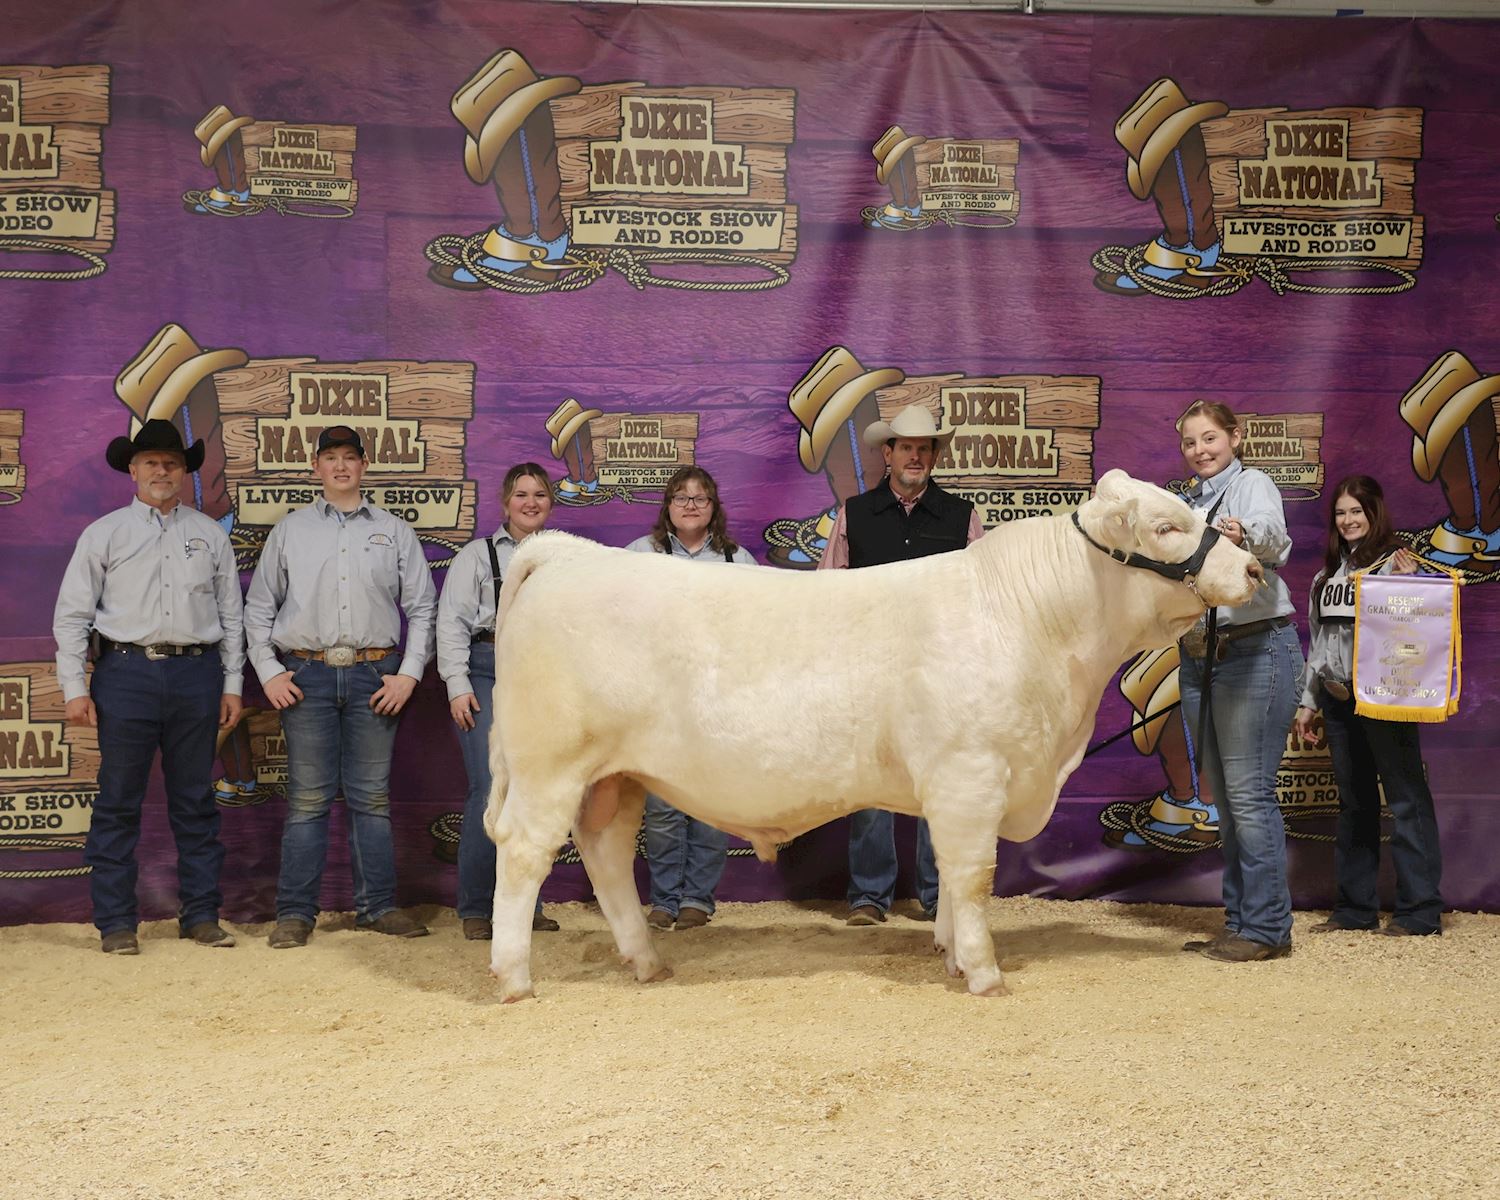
[438,462,558,942]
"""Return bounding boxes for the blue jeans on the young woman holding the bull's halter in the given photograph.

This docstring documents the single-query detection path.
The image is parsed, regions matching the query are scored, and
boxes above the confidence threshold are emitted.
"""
[1178,626,1302,947]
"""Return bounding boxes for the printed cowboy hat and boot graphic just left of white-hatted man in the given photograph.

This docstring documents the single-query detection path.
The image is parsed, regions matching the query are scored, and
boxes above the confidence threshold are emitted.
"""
[768,347,906,570]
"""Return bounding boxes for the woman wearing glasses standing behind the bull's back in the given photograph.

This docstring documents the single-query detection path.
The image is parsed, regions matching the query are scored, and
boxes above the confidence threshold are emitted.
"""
[626,467,755,929]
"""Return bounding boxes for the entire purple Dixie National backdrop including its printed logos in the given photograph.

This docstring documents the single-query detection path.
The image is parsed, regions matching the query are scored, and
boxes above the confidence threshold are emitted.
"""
[0,0,1500,923]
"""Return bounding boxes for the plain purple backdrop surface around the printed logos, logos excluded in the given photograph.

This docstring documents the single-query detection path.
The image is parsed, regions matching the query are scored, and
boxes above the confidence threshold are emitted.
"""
[0,0,1500,923]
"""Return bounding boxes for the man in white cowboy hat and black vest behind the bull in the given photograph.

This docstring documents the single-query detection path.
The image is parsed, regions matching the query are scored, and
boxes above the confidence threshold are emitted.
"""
[818,404,984,926]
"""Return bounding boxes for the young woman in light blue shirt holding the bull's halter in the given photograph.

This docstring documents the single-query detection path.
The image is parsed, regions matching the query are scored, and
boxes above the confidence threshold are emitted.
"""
[1178,401,1304,963]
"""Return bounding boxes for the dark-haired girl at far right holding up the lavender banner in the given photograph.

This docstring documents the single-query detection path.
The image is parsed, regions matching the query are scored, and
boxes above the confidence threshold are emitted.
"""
[1296,476,1443,938]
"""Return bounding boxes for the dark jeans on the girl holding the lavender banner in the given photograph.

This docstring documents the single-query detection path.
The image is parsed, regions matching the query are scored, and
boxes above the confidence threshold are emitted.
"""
[1323,696,1443,933]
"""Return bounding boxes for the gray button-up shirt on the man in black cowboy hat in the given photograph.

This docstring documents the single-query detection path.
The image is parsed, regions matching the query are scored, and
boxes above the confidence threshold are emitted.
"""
[53,498,245,701]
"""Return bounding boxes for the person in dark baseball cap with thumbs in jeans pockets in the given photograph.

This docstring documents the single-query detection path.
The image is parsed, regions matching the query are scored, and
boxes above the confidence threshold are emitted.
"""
[245,425,438,950]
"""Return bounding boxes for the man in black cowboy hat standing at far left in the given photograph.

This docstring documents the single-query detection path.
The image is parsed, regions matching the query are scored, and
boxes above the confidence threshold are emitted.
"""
[53,420,245,954]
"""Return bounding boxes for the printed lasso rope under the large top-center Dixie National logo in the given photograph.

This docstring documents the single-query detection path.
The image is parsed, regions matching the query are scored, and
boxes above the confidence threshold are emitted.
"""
[423,230,792,296]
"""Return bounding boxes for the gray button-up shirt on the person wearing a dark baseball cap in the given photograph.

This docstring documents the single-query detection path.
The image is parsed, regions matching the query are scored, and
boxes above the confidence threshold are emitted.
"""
[245,497,438,684]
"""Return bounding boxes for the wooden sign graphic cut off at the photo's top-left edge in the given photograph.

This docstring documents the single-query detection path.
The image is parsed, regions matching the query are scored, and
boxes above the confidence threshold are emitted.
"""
[0,65,116,255]
